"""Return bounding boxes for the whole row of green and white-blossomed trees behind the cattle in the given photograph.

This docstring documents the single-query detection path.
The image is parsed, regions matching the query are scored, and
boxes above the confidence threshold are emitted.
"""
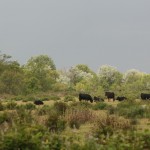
[0,54,150,98]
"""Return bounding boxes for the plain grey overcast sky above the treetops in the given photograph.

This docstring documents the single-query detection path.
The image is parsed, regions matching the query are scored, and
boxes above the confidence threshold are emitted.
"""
[0,0,150,73]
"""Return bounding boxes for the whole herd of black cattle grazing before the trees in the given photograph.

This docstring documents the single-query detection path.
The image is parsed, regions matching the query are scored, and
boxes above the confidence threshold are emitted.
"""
[34,92,150,105]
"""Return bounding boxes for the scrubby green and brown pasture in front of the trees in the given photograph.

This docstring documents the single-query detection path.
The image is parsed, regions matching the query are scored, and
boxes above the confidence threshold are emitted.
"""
[0,93,150,150]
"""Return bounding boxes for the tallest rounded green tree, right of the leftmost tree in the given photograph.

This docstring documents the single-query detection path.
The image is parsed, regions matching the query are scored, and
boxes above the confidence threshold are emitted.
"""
[24,55,58,92]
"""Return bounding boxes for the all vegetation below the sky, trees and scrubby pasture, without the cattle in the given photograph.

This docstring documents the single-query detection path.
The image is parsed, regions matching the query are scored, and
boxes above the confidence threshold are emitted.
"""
[0,54,150,150]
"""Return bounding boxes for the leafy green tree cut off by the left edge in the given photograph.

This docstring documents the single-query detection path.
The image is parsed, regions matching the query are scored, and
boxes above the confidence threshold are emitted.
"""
[0,54,24,94]
